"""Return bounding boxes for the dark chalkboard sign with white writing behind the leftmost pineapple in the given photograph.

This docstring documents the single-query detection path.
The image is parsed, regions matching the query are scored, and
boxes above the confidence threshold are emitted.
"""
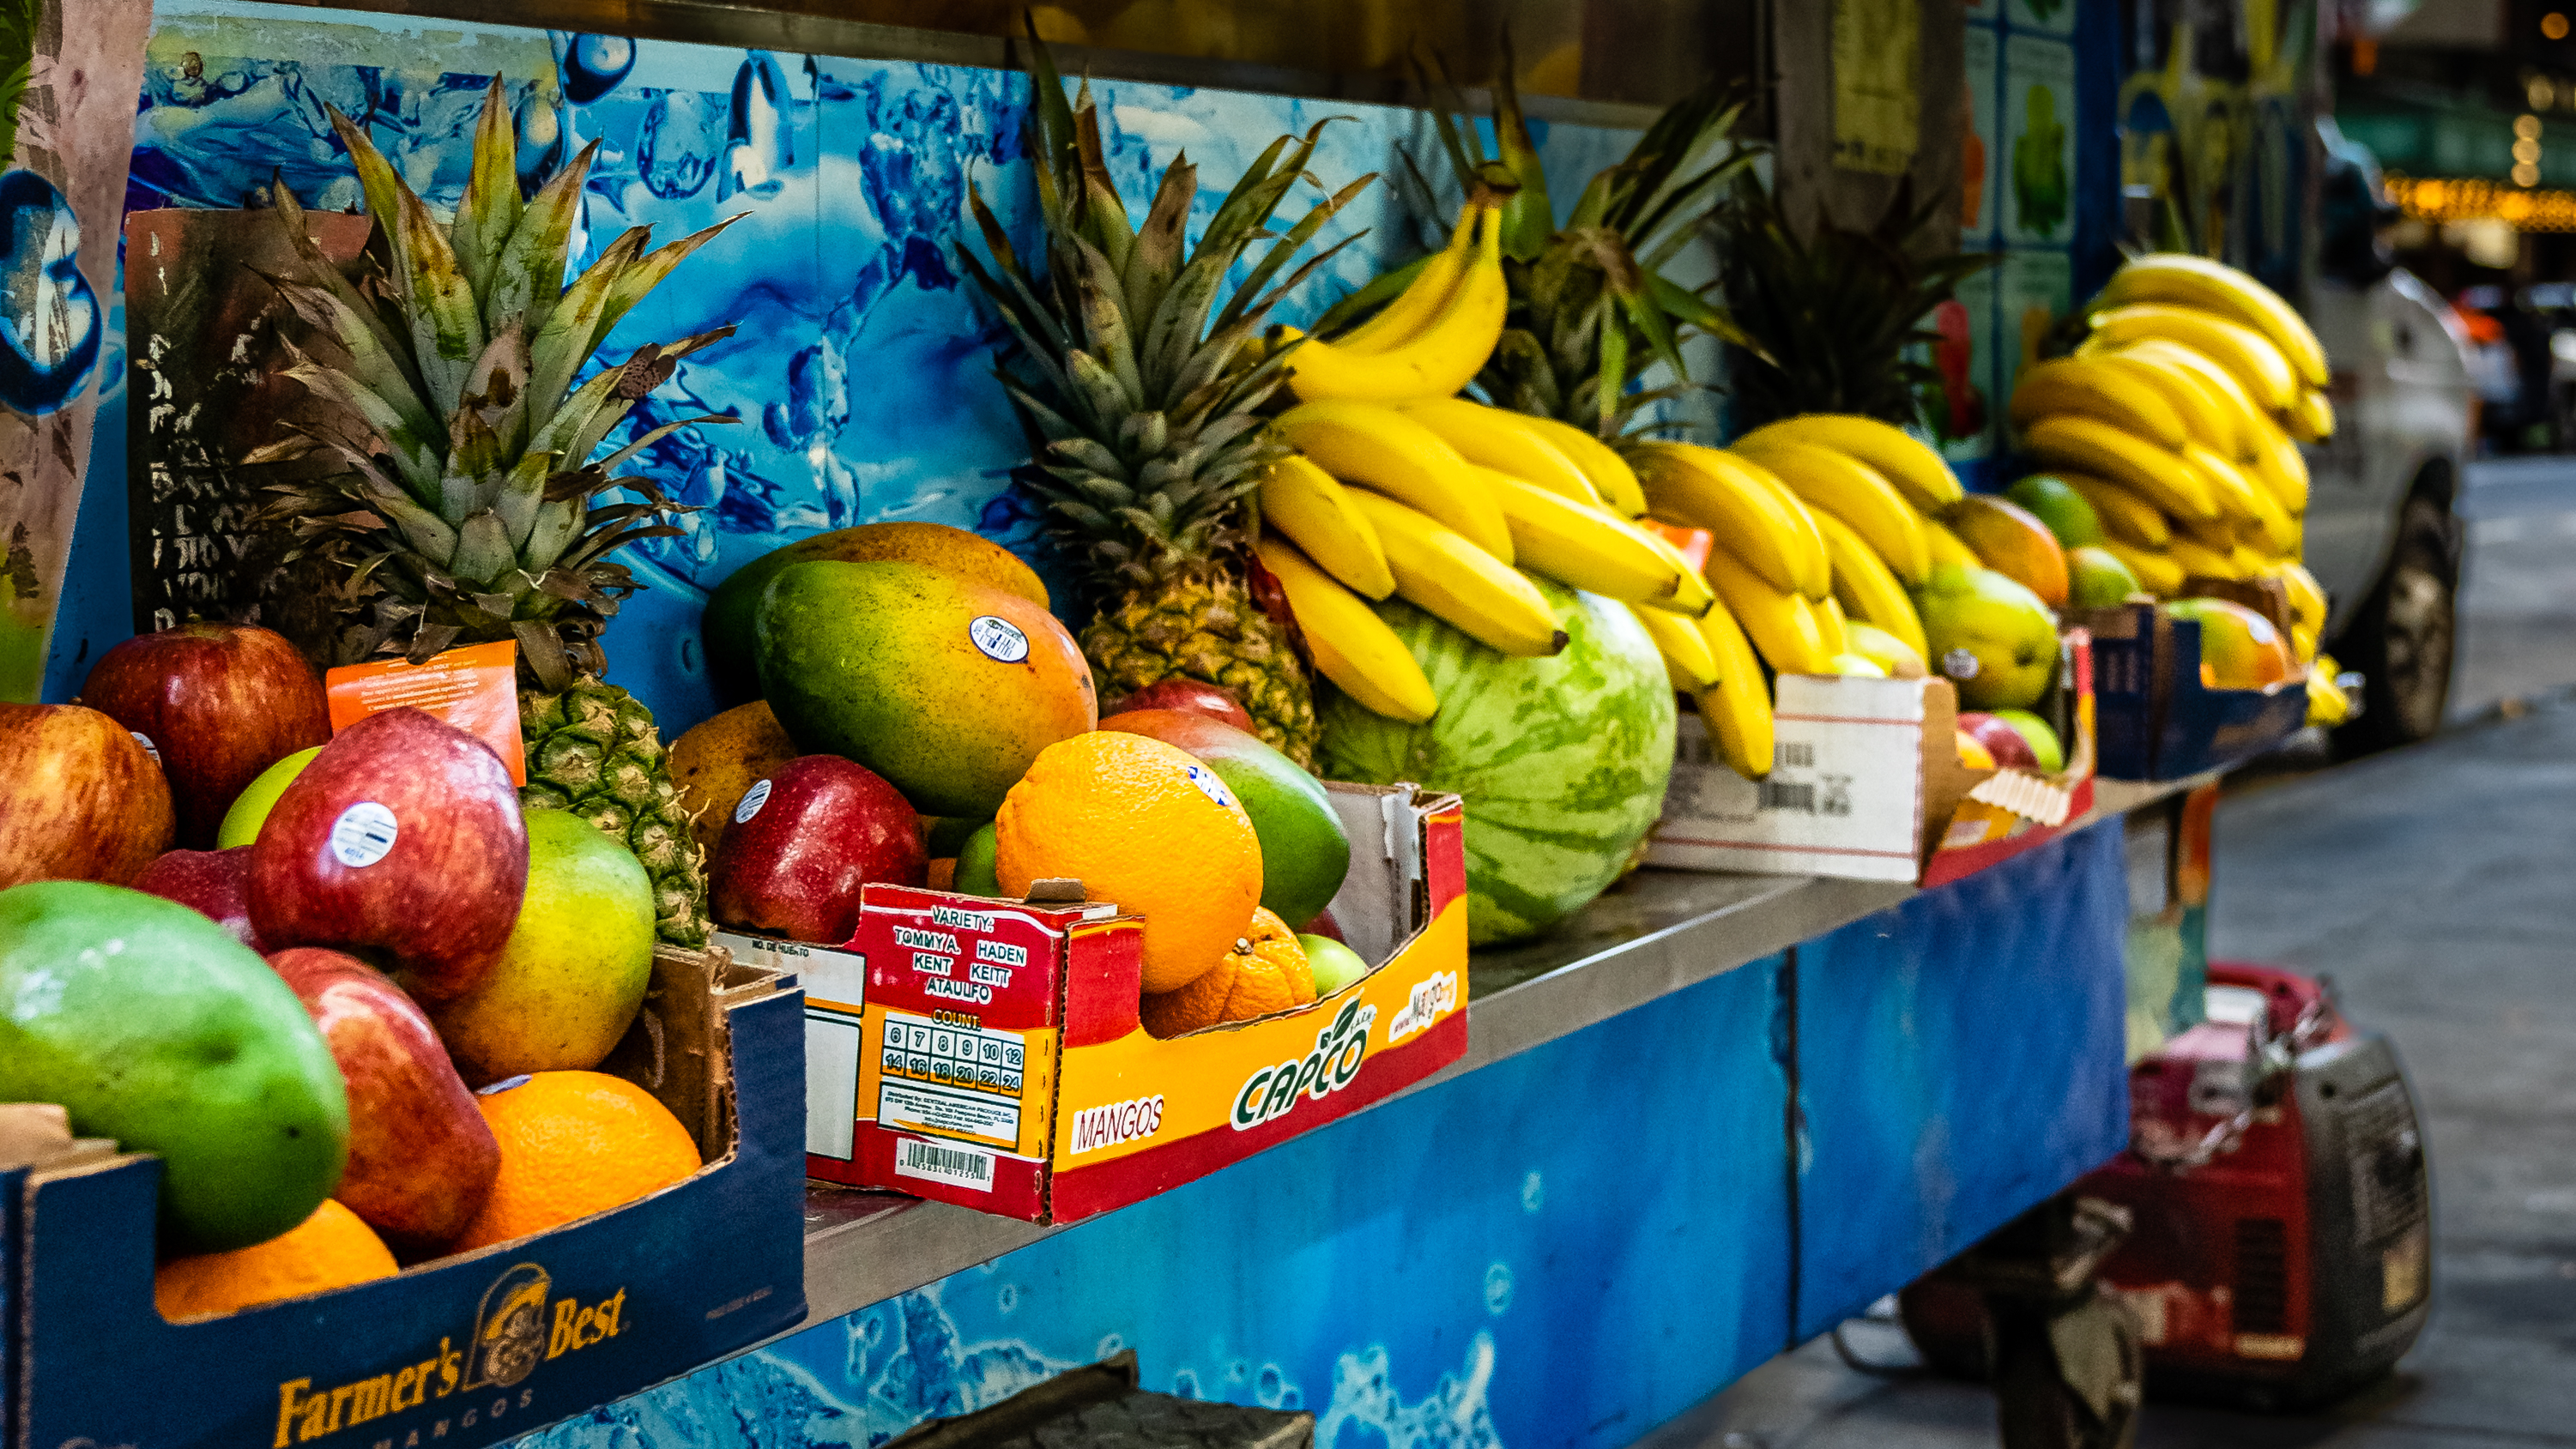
[126,208,371,667]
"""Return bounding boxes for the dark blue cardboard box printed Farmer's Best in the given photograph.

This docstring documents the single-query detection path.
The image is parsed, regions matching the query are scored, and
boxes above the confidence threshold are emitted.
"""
[0,950,807,1449]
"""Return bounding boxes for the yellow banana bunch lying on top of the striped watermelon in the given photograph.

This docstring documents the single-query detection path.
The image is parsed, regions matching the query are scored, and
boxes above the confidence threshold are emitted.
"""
[1255,203,1715,723]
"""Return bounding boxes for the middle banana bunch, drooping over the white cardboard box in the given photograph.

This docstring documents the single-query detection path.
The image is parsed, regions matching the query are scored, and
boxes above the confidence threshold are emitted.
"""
[1633,412,1976,780]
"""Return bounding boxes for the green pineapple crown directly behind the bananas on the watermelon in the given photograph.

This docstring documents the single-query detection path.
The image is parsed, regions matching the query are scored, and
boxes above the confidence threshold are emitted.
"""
[1406,31,1762,435]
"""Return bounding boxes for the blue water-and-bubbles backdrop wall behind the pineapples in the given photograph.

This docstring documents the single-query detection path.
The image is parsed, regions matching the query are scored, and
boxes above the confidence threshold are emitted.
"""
[46,0,1633,710]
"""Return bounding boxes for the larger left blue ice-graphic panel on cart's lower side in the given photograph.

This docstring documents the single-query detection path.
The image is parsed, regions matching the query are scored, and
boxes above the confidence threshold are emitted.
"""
[528,963,1787,1449]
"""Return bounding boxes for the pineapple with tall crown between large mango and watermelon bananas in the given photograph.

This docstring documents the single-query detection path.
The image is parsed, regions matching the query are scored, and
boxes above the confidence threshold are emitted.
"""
[964,39,1376,764]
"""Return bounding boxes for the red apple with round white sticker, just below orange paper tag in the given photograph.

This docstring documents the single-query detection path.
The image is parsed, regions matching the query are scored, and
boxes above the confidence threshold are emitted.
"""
[247,708,528,1001]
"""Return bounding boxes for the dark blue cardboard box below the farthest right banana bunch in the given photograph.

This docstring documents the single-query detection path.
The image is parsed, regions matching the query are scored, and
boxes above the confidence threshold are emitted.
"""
[2084,595,2308,780]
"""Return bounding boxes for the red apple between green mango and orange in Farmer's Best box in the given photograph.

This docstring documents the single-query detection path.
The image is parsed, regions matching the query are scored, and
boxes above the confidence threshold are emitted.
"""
[269,952,499,1248]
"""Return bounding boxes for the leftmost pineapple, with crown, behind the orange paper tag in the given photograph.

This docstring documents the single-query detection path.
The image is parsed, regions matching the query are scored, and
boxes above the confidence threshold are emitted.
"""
[252,80,732,947]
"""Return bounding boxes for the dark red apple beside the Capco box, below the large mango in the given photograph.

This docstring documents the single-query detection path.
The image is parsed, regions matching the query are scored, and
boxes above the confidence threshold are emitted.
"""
[706,754,930,945]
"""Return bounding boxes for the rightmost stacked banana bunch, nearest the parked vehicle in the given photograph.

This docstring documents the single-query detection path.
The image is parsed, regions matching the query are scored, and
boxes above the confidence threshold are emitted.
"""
[2012,252,2342,710]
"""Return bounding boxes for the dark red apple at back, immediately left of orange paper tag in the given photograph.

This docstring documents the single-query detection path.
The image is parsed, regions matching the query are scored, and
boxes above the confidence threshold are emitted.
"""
[80,623,330,849]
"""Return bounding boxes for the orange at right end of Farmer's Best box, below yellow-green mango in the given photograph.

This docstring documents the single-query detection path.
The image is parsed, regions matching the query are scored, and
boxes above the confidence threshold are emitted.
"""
[448,1071,698,1253]
